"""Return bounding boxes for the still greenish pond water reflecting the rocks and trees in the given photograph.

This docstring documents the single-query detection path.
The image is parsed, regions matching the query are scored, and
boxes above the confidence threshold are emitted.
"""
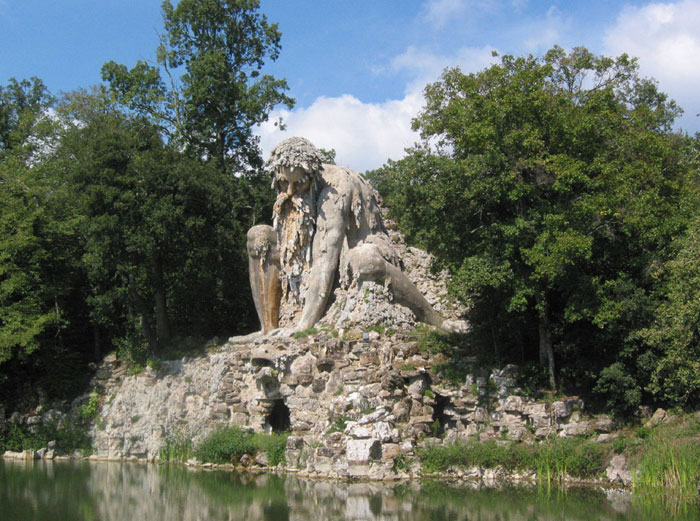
[0,459,700,521]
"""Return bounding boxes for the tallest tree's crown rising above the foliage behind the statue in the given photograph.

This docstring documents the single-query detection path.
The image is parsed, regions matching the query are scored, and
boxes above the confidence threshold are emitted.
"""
[102,0,294,171]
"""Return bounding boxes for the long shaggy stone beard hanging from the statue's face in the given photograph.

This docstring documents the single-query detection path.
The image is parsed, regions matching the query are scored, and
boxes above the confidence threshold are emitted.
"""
[273,191,316,311]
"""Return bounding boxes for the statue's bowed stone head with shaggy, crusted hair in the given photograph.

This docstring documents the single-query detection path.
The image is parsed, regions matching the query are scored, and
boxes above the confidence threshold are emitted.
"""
[265,137,322,197]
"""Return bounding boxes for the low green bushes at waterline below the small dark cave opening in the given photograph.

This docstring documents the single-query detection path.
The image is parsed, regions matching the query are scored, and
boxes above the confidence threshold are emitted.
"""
[191,427,288,466]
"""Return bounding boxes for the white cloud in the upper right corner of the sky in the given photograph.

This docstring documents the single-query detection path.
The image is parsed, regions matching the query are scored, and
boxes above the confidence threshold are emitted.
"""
[604,0,700,131]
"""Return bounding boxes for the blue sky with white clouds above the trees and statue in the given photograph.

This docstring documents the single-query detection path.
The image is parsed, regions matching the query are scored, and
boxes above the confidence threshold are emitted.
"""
[0,0,700,171]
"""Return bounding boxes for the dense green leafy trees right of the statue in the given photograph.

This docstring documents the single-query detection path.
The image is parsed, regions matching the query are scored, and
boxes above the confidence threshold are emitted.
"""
[368,47,700,413]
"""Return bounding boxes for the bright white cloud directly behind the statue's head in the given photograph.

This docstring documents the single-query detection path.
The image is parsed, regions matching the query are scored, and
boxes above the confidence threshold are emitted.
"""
[257,47,495,172]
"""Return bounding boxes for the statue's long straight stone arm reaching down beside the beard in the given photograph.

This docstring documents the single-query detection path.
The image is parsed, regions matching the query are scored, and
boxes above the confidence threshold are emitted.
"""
[299,189,349,330]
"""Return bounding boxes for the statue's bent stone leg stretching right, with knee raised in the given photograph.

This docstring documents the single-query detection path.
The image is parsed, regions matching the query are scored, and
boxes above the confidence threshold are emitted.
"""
[345,243,445,327]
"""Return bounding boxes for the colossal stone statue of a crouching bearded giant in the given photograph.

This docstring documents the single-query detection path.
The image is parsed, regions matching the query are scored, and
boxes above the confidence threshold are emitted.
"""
[248,137,452,334]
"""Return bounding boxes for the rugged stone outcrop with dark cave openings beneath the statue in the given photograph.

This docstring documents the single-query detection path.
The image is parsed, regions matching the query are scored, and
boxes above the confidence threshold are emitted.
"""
[82,331,605,479]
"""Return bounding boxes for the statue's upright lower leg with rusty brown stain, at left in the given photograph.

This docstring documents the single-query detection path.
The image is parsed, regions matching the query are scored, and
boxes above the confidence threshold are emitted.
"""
[247,225,282,333]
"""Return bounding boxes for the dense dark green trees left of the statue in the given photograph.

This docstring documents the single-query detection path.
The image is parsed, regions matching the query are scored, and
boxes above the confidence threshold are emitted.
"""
[0,0,293,411]
